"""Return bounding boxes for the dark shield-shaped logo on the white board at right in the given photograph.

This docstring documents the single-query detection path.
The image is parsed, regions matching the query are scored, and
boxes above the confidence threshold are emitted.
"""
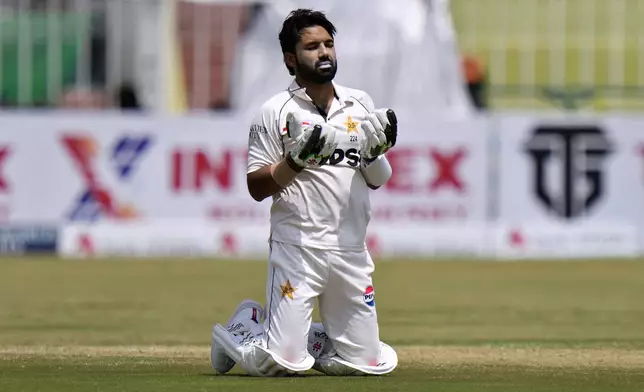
[525,126,611,219]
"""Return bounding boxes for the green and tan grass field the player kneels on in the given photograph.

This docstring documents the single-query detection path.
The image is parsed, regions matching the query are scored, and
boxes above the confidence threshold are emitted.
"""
[0,258,644,392]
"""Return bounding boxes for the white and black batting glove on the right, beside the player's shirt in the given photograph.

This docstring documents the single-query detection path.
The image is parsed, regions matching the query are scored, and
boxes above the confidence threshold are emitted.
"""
[360,109,398,160]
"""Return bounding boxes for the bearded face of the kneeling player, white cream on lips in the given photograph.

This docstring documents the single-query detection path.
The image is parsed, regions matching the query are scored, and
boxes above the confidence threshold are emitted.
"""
[290,26,338,84]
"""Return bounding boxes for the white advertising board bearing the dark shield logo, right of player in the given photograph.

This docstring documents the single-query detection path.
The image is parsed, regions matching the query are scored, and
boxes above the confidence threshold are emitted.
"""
[492,114,644,253]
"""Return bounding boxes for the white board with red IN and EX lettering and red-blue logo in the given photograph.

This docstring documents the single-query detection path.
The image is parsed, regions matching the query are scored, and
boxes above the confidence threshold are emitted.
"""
[0,115,486,224]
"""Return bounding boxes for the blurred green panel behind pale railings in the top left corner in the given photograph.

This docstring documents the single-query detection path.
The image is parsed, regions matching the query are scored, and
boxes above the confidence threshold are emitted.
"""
[0,12,91,106]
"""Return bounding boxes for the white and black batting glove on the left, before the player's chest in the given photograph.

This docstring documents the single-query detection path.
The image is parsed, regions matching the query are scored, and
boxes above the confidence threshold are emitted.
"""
[286,113,338,167]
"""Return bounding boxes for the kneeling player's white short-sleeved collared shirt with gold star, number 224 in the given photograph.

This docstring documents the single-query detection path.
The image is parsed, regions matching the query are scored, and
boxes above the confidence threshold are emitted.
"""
[247,81,374,250]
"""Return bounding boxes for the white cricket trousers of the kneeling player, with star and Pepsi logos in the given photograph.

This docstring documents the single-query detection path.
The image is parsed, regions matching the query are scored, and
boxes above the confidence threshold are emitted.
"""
[264,241,380,366]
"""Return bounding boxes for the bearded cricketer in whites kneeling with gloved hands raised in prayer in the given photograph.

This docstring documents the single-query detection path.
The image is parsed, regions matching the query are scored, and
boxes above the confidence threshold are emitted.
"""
[211,9,398,376]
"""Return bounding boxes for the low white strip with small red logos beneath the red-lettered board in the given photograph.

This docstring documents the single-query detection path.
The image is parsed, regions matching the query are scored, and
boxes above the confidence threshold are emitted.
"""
[58,220,494,261]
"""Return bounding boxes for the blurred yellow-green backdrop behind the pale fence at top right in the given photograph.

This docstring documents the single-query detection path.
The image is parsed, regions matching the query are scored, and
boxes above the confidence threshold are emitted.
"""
[451,0,644,111]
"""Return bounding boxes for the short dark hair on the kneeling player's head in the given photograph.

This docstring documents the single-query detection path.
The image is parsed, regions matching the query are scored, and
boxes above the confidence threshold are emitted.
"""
[279,8,336,75]
